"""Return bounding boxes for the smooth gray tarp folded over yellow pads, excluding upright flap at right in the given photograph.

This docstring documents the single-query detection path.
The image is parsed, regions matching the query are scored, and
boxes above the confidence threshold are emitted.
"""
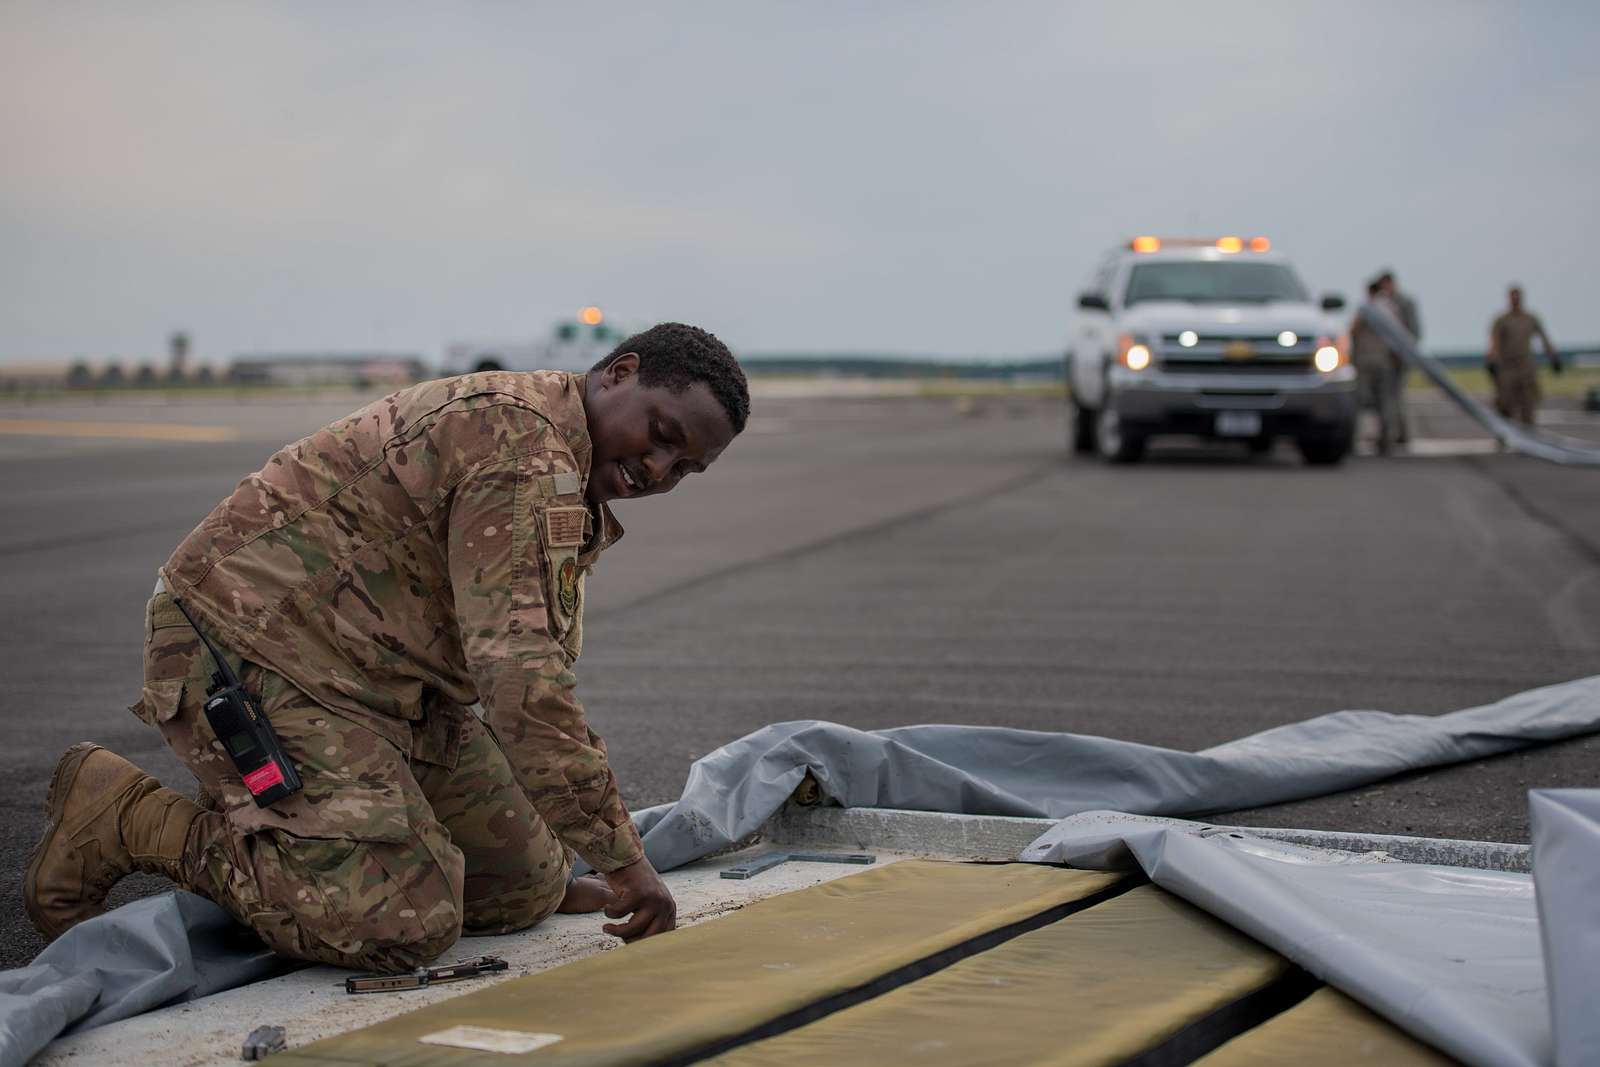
[1021,813,1548,1067]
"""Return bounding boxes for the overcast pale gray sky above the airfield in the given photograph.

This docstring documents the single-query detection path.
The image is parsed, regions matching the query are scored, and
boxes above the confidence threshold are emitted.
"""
[0,0,1600,367]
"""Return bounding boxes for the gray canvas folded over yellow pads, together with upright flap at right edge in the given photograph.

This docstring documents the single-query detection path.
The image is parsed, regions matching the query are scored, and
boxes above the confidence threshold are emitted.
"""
[1021,789,1600,1067]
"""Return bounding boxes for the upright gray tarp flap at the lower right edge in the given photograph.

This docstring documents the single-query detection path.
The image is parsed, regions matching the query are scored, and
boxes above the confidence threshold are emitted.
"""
[1528,789,1600,1067]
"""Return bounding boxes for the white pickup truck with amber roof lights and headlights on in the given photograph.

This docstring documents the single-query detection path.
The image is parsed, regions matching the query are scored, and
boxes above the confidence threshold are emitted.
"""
[1069,237,1355,464]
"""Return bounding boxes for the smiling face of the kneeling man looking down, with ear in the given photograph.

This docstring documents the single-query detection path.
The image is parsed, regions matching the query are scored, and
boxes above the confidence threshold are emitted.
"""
[584,352,733,504]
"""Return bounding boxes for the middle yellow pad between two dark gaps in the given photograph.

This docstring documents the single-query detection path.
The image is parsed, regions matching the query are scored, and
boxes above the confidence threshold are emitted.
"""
[706,886,1298,1067]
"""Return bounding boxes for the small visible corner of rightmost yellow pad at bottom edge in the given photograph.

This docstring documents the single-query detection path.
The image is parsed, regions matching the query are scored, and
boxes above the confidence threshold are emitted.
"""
[1195,989,1456,1067]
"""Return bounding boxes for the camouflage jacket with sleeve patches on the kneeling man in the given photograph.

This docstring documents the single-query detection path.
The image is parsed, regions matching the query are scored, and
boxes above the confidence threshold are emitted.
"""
[162,371,643,870]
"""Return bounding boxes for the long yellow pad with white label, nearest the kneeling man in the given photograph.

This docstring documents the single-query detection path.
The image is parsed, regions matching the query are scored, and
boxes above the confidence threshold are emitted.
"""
[272,861,1122,1067]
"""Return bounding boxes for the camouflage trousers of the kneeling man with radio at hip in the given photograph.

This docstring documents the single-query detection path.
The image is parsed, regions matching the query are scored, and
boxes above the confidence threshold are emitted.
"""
[131,592,571,971]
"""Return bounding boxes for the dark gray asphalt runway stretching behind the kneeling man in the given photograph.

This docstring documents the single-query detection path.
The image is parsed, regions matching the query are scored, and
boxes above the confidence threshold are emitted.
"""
[0,386,1600,966]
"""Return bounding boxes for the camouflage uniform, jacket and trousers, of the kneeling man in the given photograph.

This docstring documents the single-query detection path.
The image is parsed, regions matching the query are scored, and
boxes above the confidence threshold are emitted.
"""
[134,371,643,969]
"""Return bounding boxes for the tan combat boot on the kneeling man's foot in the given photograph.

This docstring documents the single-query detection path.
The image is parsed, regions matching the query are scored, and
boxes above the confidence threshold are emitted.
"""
[22,741,200,941]
